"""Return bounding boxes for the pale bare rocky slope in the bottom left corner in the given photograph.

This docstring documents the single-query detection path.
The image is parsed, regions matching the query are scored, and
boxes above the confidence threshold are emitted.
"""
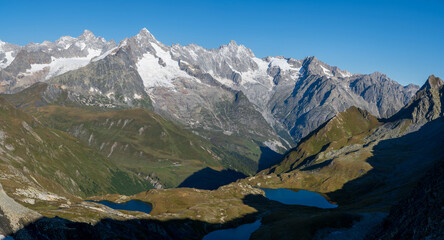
[0,184,41,236]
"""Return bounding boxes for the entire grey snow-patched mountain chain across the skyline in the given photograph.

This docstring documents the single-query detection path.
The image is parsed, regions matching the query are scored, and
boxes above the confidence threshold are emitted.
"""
[0,29,418,148]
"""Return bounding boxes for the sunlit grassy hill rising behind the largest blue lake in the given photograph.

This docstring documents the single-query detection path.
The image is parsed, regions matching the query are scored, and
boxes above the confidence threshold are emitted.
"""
[236,107,381,195]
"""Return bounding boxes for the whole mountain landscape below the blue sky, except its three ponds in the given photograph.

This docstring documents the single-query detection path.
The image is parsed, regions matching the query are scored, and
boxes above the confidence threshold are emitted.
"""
[0,28,444,240]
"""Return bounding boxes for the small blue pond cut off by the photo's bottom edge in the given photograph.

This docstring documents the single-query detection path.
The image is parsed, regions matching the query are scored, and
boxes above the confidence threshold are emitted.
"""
[202,219,261,240]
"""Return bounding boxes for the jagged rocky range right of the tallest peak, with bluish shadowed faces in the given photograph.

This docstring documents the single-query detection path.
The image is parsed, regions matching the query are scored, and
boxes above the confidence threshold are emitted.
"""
[166,42,418,141]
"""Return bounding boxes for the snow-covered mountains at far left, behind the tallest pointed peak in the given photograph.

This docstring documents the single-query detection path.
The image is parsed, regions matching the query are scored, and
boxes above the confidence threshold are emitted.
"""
[0,30,116,91]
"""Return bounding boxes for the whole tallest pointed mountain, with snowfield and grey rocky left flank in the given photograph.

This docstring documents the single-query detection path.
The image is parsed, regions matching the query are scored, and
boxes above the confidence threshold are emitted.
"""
[22,30,284,173]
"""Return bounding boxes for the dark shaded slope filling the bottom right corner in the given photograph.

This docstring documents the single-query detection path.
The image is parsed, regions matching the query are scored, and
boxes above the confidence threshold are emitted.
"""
[367,157,444,239]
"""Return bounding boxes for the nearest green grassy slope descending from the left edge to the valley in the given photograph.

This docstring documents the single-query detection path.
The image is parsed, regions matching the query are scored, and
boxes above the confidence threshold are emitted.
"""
[0,98,149,196]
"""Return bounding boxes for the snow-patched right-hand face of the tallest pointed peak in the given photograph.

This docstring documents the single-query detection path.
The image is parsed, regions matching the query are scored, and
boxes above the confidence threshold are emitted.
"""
[114,29,278,141]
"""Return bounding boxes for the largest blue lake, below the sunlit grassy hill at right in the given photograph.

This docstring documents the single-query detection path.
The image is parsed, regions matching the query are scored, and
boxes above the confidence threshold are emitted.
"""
[262,188,338,208]
